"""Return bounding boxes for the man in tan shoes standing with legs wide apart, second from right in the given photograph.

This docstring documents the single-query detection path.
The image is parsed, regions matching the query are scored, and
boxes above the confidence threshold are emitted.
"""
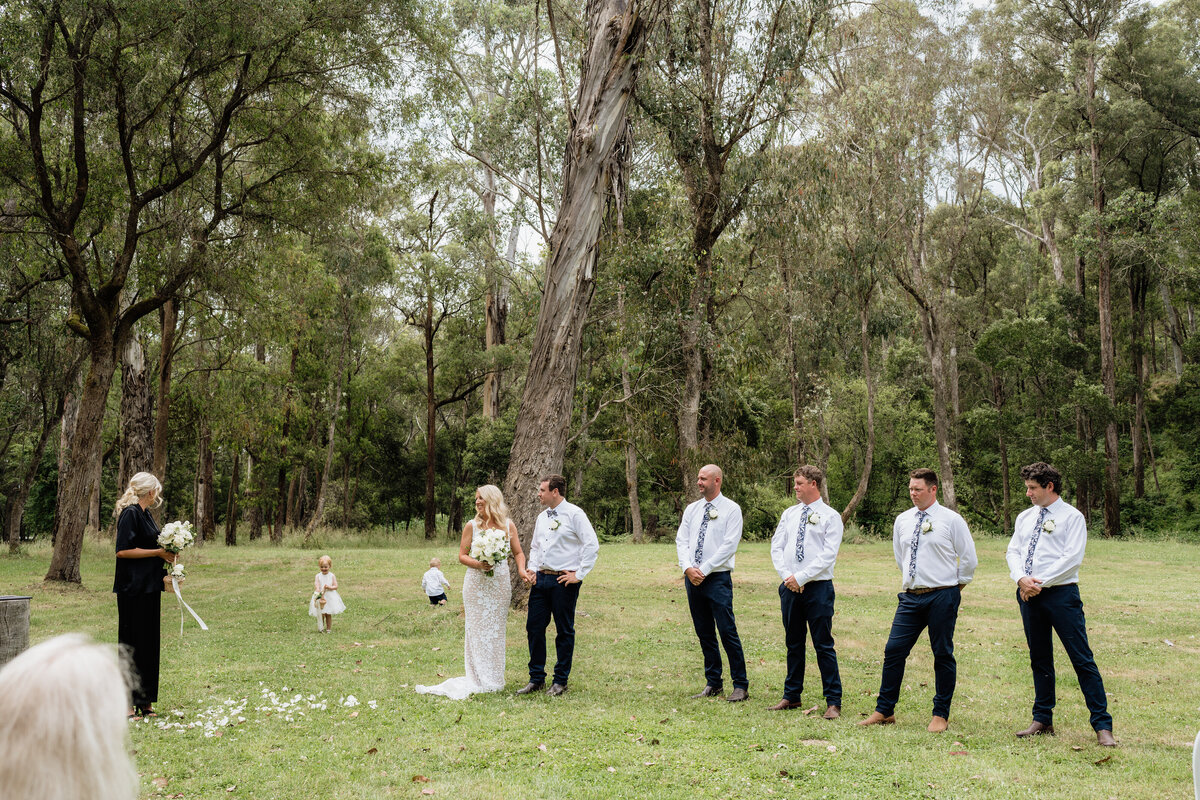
[858,469,978,733]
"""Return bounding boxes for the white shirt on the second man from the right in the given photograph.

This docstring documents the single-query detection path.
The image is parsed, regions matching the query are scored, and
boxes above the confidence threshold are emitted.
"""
[892,500,979,590]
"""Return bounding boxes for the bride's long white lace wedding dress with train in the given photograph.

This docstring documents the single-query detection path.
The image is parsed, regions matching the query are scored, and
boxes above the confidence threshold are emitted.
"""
[416,521,512,700]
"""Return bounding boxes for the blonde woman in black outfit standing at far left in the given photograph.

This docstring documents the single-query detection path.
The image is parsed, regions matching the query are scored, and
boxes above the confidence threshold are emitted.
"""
[113,473,175,716]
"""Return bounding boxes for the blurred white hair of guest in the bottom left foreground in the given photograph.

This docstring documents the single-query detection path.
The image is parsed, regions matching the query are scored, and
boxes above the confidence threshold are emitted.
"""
[0,633,138,800]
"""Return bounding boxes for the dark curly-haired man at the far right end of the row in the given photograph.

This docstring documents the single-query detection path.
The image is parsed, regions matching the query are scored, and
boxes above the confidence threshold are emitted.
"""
[1006,462,1117,747]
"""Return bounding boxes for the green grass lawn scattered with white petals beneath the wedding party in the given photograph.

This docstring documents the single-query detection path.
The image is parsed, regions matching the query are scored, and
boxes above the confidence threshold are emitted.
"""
[0,539,1200,800]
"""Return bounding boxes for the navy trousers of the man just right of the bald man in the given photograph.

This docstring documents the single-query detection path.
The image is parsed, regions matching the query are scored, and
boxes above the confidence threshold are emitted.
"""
[779,581,841,706]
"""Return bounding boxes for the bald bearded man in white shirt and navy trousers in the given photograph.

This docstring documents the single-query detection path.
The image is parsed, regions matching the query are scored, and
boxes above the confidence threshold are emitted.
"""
[676,464,750,703]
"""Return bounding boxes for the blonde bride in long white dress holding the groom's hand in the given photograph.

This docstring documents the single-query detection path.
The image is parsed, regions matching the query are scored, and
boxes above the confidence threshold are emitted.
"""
[416,485,526,700]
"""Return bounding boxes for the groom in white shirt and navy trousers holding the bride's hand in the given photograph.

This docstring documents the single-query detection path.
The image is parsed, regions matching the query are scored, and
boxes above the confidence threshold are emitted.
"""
[517,475,600,697]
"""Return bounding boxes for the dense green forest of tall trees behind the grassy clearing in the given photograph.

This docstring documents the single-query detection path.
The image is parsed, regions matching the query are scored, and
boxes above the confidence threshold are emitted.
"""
[0,0,1200,579]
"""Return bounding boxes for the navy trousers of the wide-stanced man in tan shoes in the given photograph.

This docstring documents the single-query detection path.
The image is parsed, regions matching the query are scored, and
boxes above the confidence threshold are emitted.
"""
[875,587,962,720]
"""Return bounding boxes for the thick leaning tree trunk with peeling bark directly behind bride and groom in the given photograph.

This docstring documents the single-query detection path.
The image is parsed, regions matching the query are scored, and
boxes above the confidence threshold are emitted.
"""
[504,0,649,608]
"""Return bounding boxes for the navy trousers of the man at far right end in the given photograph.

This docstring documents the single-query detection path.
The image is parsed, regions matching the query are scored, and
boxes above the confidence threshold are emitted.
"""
[1016,583,1112,730]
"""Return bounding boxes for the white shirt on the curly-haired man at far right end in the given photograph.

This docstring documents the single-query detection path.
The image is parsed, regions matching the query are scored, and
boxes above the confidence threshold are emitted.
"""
[1004,498,1087,587]
